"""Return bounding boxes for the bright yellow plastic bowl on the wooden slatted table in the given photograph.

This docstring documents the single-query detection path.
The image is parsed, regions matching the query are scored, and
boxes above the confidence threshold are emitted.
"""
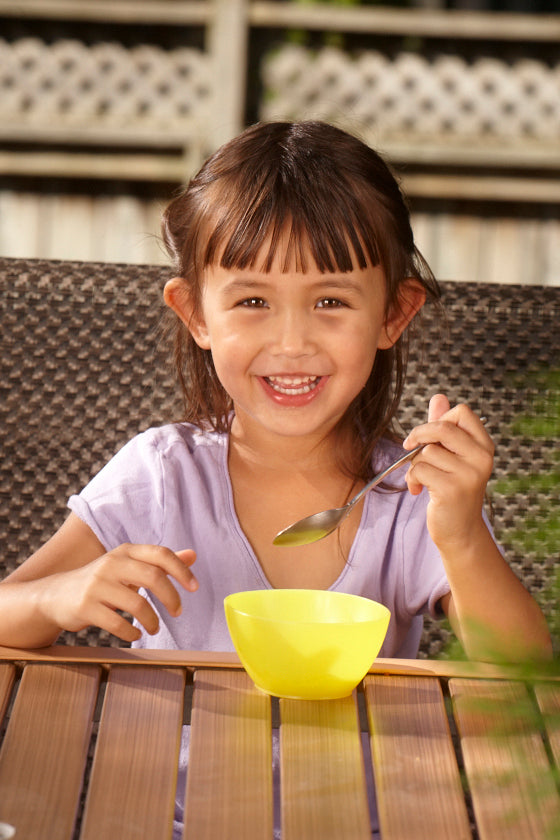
[224,589,390,700]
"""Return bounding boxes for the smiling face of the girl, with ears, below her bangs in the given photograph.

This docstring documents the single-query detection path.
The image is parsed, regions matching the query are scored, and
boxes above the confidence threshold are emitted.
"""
[166,240,423,452]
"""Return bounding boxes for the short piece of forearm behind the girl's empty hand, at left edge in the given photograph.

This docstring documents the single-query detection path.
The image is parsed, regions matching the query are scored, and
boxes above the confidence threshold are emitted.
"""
[0,579,62,648]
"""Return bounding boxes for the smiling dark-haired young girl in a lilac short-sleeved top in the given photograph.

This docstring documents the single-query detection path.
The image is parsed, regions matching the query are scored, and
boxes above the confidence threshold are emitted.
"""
[0,123,550,659]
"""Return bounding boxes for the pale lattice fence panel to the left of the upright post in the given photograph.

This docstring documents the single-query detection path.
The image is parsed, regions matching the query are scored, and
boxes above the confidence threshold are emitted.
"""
[0,38,211,146]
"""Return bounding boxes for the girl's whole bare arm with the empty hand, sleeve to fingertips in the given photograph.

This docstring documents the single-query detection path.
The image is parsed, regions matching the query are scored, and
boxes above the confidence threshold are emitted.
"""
[0,513,197,648]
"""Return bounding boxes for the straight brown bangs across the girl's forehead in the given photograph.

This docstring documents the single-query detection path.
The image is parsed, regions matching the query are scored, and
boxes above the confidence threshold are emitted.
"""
[197,153,380,273]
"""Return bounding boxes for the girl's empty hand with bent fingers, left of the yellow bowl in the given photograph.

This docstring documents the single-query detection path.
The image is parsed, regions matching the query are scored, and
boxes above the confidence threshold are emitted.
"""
[40,543,198,642]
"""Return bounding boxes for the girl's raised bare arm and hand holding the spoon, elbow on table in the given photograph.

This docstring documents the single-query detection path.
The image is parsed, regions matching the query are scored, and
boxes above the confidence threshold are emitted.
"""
[406,395,552,661]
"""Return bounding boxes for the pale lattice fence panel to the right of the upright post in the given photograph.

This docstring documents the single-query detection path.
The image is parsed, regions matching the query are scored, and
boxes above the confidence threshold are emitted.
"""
[261,46,560,163]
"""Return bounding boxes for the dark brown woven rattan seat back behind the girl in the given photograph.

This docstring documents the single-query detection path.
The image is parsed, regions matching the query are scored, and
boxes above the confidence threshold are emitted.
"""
[0,259,560,655]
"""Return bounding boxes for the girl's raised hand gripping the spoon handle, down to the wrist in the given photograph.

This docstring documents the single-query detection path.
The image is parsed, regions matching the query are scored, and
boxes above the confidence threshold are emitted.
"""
[403,394,494,551]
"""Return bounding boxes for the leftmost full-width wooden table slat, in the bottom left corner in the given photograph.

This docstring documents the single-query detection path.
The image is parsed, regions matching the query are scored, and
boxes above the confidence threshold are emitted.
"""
[0,665,100,840]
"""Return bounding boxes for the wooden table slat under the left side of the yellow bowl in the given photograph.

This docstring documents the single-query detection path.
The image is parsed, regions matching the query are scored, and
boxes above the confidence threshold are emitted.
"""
[184,671,273,840]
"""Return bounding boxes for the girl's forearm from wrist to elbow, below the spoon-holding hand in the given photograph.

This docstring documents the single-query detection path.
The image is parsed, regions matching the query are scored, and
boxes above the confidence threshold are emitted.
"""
[442,523,552,662]
